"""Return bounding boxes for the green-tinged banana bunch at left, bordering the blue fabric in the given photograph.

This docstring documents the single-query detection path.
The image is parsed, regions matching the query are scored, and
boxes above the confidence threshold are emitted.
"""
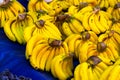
[4,13,34,44]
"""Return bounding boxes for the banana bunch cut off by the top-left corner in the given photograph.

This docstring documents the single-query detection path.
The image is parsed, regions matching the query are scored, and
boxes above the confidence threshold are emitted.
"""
[0,0,25,27]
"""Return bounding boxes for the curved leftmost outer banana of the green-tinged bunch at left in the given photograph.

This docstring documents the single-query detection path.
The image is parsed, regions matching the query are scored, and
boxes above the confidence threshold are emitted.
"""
[3,18,16,41]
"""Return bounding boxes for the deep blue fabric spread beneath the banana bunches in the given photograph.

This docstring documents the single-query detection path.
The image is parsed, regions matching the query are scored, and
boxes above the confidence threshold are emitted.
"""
[0,0,78,80]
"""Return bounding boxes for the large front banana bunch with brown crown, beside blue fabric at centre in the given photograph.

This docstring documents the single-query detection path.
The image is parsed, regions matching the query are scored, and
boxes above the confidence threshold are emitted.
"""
[26,35,69,71]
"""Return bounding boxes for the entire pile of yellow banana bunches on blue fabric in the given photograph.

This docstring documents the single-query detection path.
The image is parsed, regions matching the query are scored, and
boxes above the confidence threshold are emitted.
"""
[0,0,120,80]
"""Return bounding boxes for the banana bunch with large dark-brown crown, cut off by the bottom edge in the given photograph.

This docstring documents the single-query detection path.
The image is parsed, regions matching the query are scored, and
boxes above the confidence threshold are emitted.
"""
[73,56,116,80]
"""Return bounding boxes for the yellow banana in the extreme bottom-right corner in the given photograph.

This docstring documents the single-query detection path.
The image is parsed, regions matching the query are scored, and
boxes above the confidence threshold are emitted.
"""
[108,65,120,80]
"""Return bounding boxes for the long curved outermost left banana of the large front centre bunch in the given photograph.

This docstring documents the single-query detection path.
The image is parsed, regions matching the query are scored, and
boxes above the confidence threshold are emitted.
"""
[25,35,45,59]
